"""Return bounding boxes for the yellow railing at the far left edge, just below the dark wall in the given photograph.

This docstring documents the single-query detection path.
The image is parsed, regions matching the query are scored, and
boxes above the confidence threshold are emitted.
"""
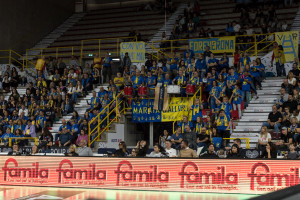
[0,49,36,73]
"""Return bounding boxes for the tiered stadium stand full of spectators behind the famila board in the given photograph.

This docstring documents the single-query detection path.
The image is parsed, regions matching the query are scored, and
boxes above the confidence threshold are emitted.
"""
[0,0,300,161]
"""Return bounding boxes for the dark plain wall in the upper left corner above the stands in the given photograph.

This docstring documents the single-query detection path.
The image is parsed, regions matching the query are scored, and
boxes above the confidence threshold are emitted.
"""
[0,0,75,53]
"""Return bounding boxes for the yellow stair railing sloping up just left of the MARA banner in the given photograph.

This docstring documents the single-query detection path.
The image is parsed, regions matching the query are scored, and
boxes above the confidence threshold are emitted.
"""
[88,92,122,146]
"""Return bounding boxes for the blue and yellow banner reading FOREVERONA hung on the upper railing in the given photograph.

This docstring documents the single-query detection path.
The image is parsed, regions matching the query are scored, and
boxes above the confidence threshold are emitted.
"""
[189,36,235,54]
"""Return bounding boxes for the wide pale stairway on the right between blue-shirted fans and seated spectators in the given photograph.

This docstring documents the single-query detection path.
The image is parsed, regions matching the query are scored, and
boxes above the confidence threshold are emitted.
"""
[231,78,283,149]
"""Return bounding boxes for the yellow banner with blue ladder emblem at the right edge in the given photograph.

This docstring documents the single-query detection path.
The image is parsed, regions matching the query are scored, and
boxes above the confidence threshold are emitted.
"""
[275,31,299,62]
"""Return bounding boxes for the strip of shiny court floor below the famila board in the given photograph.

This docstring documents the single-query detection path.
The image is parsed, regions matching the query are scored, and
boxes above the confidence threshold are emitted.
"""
[0,186,256,200]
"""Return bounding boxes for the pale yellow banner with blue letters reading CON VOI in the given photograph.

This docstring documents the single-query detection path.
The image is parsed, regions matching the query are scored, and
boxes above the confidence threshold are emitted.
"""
[120,42,145,63]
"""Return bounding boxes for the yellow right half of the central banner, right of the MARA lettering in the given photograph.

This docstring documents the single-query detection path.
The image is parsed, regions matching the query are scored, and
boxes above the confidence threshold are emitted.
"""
[161,97,191,122]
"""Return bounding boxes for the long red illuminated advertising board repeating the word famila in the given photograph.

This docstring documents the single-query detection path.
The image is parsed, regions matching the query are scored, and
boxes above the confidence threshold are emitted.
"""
[0,156,300,194]
